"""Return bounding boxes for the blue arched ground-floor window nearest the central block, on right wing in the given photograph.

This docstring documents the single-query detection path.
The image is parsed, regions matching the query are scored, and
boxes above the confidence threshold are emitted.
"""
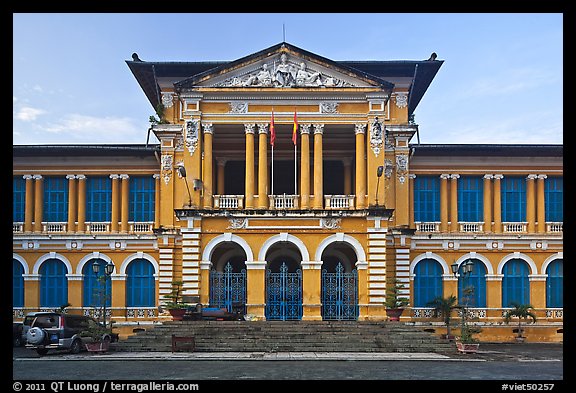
[414,259,442,307]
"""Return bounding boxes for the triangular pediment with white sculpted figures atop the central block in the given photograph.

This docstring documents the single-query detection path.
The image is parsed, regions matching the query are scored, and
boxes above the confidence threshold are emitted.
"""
[175,43,393,89]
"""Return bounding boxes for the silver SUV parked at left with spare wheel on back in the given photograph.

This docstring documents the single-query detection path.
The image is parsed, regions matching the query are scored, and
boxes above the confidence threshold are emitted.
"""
[26,312,118,355]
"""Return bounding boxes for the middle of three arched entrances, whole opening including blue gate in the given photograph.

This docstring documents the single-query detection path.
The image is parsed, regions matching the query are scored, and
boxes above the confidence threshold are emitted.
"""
[265,241,302,321]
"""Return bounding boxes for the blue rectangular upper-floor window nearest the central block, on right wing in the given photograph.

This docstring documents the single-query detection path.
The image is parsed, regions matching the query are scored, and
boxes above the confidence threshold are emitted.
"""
[414,175,440,222]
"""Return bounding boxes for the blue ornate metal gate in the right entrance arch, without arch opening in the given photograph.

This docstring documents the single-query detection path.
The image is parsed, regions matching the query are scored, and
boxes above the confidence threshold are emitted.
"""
[322,262,358,321]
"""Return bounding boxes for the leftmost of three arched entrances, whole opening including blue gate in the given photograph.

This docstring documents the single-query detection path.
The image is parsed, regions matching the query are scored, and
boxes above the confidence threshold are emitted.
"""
[209,242,246,314]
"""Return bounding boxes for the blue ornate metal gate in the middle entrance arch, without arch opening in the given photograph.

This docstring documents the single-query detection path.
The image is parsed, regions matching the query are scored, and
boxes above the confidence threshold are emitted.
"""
[265,262,302,321]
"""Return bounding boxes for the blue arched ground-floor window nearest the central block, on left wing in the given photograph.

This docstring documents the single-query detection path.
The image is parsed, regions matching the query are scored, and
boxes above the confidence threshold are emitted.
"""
[126,259,156,307]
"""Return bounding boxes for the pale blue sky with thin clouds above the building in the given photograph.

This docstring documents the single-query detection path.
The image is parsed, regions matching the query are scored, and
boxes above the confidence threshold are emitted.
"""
[13,13,563,145]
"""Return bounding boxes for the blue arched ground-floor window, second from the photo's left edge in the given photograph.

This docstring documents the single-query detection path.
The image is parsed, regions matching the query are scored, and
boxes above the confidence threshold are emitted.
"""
[40,259,68,307]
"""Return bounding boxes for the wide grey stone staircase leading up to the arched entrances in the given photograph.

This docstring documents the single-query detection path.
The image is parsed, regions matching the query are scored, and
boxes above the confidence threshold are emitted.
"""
[111,321,456,354]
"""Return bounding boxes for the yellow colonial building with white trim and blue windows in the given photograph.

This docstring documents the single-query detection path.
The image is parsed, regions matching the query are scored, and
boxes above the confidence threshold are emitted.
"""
[13,43,563,341]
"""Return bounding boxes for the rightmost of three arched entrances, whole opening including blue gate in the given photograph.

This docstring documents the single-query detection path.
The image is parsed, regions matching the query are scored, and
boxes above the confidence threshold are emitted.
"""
[321,242,359,321]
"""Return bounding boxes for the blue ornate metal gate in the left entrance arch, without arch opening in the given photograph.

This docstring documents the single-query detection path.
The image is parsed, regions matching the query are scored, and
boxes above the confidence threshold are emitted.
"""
[210,262,246,314]
